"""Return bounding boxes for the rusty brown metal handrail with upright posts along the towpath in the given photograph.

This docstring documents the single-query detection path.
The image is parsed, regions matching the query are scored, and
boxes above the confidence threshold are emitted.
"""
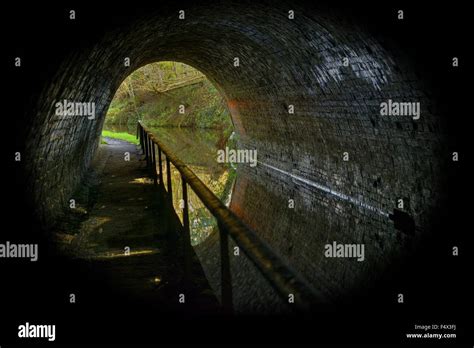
[137,122,319,311]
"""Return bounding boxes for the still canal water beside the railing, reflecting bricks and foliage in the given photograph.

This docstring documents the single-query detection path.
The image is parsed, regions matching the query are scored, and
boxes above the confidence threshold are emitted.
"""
[102,123,406,313]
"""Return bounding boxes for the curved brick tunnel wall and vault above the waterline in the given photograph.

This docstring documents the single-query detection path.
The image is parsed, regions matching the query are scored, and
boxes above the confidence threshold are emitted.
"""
[21,2,446,308]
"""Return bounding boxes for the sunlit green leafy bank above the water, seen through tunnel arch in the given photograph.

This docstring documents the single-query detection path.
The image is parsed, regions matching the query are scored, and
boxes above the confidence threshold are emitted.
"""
[105,62,233,134]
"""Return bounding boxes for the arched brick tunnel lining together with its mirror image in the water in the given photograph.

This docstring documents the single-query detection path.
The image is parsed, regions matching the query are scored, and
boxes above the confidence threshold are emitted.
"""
[7,1,470,338]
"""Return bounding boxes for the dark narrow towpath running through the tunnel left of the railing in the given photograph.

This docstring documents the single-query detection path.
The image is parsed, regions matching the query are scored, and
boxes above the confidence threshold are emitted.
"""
[57,138,217,311]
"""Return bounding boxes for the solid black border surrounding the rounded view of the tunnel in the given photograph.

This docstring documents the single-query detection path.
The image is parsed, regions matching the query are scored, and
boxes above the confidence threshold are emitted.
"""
[0,1,473,347]
